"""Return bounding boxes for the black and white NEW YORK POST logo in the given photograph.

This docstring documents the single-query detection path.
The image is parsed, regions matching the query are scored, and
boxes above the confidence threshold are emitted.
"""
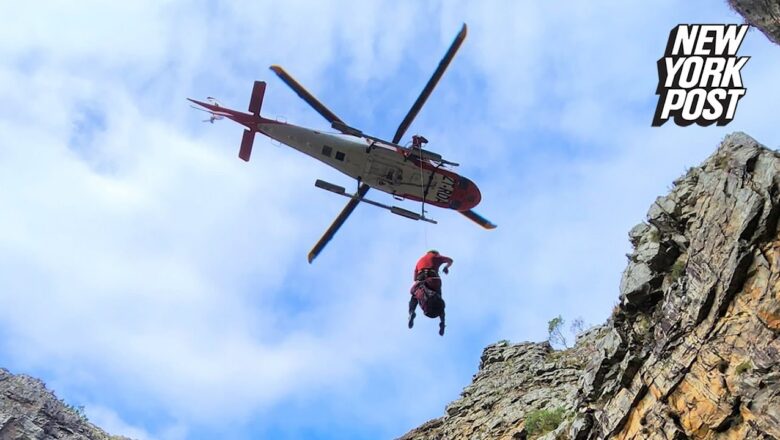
[653,24,750,127]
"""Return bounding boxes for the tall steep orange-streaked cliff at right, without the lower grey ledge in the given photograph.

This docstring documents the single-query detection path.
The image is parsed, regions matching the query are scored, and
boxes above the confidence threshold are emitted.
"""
[572,133,780,439]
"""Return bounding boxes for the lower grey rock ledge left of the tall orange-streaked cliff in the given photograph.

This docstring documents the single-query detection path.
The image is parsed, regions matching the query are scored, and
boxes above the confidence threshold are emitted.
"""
[401,327,606,440]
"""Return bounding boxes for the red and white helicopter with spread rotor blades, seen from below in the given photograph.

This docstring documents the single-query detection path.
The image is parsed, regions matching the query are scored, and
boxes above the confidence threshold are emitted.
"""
[187,23,496,263]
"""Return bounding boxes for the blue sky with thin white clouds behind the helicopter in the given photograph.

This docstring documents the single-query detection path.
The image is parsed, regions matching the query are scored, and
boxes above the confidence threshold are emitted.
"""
[0,0,780,440]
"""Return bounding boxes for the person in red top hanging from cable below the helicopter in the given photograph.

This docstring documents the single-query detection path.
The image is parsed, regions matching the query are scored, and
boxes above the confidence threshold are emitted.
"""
[409,250,453,336]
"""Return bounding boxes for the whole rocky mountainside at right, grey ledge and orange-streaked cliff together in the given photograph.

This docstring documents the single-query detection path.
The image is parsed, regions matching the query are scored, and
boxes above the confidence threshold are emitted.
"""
[402,133,780,440]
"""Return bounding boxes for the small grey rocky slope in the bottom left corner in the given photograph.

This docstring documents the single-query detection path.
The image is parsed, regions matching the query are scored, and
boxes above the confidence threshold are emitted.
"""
[0,368,130,440]
